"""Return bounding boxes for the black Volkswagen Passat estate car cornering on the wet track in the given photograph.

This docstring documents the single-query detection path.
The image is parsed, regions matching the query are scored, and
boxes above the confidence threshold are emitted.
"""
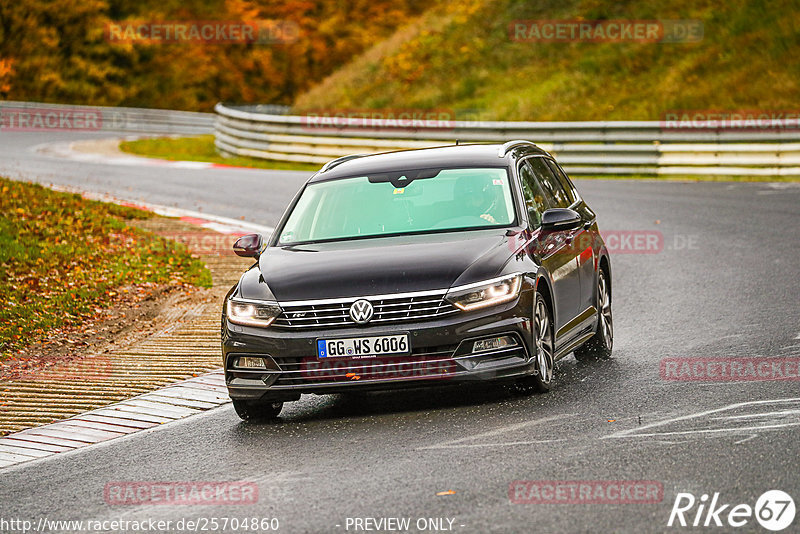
[222,141,613,419]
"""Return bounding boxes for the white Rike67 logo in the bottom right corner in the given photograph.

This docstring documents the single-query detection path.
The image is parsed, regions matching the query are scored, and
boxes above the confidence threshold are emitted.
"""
[667,490,795,532]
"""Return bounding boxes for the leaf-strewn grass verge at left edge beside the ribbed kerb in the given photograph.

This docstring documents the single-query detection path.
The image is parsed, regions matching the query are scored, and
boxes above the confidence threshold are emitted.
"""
[0,178,211,360]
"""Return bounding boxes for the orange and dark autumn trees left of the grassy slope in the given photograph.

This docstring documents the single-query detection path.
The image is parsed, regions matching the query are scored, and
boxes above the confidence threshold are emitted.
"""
[0,0,430,110]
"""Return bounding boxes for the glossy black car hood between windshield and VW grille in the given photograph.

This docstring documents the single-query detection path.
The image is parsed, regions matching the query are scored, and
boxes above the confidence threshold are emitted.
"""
[241,229,512,302]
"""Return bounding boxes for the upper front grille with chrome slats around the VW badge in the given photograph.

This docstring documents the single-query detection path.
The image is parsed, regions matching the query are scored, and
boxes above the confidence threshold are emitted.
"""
[273,291,458,328]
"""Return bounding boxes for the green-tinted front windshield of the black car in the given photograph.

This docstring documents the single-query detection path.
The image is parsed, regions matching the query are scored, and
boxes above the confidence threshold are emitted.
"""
[279,168,515,244]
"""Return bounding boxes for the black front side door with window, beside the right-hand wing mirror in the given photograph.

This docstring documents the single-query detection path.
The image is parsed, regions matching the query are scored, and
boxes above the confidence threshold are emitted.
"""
[519,157,580,338]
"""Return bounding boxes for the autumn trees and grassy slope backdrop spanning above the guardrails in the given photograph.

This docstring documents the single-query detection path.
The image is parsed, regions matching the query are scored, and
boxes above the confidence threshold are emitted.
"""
[0,0,800,120]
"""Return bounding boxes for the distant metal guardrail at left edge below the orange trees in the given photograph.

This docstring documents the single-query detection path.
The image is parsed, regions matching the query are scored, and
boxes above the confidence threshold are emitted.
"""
[0,101,214,135]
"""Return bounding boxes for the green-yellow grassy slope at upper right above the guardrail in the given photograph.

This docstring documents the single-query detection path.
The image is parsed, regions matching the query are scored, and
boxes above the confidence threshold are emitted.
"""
[295,0,800,121]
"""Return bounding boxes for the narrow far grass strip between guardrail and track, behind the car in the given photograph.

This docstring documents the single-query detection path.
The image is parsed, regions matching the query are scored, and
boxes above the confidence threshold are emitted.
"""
[119,135,321,171]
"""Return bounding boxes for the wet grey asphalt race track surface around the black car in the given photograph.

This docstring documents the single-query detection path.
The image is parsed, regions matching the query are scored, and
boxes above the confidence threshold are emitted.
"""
[0,132,800,533]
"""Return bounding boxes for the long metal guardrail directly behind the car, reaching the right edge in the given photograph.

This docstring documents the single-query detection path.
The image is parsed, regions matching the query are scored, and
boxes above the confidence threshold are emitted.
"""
[214,104,800,176]
